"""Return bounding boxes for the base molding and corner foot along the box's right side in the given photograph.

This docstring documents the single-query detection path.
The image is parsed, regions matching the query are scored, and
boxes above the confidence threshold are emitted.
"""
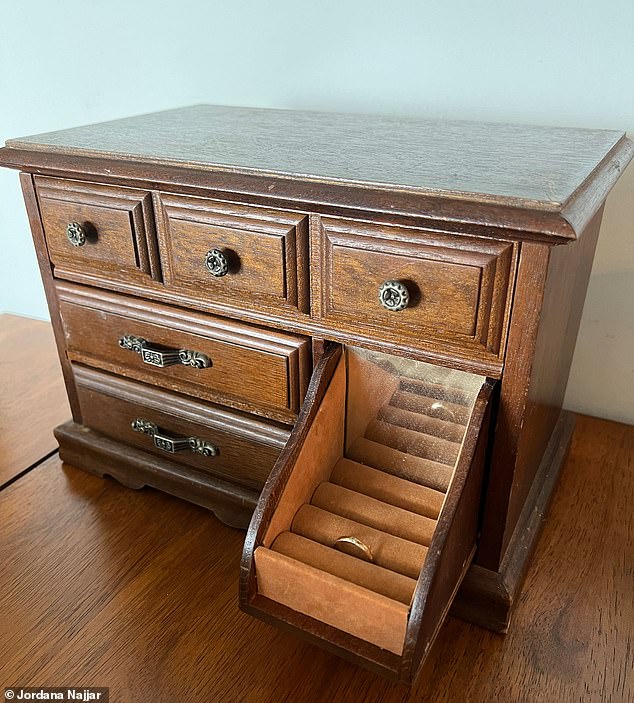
[450,411,575,633]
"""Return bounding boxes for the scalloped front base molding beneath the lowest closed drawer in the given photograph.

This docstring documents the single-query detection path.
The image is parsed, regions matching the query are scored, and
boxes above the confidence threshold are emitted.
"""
[55,421,258,529]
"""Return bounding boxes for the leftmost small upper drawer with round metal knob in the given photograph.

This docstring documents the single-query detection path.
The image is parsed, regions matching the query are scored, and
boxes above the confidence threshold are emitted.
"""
[35,177,160,283]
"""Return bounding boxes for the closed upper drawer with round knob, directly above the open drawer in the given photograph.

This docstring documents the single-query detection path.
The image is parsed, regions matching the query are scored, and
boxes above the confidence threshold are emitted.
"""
[311,217,515,358]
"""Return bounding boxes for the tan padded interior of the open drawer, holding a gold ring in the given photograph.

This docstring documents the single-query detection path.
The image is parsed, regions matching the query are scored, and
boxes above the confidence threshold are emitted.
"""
[255,347,485,654]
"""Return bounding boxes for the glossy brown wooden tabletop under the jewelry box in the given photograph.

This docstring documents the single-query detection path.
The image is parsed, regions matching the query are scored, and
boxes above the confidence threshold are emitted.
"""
[0,318,634,703]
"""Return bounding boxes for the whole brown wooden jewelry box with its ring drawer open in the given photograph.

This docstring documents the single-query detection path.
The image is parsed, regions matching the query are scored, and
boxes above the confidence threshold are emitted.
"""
[0,105,633,683]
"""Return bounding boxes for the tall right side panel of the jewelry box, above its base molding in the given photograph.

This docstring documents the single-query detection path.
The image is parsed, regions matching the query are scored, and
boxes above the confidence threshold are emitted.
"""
[478,208,602,570]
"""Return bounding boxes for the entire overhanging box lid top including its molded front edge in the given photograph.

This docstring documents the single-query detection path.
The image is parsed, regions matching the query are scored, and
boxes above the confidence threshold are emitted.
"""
[0,105,634,241]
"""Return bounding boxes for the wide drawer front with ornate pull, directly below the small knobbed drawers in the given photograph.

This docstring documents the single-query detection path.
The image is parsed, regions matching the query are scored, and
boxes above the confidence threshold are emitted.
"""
[57,284,310,422]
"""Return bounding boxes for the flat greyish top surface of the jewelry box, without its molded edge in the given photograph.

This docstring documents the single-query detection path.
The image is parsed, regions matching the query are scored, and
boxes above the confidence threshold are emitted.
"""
[7,105,624,212]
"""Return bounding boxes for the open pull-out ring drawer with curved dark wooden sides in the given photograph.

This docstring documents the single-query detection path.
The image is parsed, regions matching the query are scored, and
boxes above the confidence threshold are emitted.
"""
[240,346,493,683]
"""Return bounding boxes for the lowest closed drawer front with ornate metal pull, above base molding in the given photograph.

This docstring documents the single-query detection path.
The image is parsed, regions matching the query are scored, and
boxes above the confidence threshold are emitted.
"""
[73,365,288,490]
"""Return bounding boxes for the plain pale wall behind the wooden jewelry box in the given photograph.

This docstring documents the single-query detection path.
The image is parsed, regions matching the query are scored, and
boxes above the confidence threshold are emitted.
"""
[0,0,634,423]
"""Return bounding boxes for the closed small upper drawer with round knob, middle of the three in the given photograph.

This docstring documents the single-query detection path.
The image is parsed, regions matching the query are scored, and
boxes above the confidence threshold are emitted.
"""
[159,193,309,312]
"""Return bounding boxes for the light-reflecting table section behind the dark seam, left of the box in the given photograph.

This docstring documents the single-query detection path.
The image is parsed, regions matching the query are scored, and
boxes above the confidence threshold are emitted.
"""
[0,315,70,486]
